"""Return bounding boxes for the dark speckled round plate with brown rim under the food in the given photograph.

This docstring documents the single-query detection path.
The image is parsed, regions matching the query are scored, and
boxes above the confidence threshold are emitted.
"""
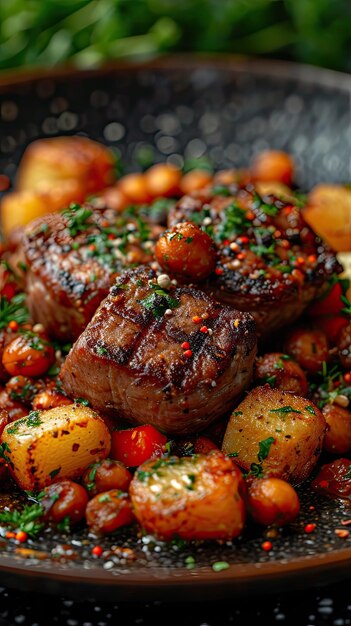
[0,57,351,600]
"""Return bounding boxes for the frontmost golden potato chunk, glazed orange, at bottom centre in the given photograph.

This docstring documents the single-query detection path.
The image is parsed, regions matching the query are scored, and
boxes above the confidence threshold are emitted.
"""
[130,450,245,540]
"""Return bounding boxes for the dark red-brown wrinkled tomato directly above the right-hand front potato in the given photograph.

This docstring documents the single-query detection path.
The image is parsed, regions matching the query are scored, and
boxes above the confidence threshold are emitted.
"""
[254,352,308,396]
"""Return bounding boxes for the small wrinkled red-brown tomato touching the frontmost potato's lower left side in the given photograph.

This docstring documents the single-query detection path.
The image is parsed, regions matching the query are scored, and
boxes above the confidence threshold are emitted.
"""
[86,489,135,534]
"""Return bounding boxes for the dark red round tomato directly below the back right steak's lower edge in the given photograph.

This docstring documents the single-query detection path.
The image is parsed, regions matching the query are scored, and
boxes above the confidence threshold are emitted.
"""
[285,328,329,374]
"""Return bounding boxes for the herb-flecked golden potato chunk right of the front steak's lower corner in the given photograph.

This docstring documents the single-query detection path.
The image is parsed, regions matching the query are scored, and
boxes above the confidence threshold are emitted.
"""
[222,385,326,484]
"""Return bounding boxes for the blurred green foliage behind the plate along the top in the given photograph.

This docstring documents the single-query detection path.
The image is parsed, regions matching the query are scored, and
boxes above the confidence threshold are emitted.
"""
[0,0,351,71]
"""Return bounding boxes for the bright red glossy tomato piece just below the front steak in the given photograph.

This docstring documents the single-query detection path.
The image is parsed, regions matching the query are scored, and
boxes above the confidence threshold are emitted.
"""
[110,424,167,467]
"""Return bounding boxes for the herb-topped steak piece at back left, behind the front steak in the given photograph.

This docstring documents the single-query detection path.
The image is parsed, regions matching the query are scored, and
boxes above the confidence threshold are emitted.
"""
[23,204,160,341]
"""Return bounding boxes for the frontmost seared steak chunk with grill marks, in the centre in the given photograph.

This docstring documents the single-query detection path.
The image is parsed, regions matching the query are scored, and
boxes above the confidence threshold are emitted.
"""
[60,267,256,434]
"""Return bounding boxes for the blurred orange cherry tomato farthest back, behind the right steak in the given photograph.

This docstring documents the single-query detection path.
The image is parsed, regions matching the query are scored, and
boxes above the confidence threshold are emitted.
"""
[251,150,294,186]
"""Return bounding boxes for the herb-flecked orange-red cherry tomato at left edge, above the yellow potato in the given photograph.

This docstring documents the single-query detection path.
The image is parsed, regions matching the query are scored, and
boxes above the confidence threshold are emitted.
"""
[2,331,55,377]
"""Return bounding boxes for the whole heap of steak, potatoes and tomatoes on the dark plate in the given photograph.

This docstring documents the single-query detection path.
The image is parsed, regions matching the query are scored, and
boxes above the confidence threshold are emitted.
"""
[0,137,351,556]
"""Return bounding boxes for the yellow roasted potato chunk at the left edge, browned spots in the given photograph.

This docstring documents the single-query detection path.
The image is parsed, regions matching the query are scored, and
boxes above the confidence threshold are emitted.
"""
[2,404,111,491]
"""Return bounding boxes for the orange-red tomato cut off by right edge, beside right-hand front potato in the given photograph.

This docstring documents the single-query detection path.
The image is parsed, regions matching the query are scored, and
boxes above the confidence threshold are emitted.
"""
[322,404,351,454]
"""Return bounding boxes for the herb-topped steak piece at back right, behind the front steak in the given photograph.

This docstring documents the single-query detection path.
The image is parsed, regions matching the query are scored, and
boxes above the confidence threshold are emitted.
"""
[168,185,342,336]
